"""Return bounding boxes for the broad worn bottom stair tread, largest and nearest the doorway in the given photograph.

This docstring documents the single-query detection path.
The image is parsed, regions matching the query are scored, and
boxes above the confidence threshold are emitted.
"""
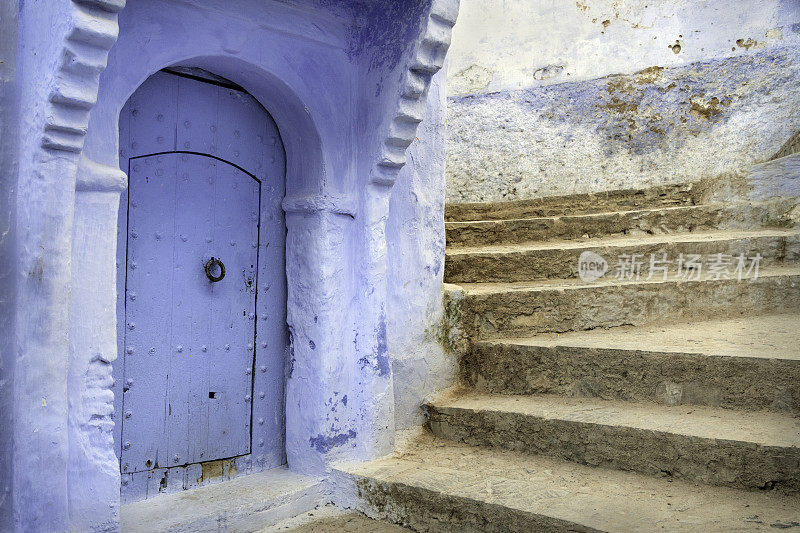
[340,434,800,531]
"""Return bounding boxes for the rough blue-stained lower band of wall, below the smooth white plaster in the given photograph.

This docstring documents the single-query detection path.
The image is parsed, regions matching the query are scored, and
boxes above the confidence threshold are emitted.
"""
[447,46,800,204]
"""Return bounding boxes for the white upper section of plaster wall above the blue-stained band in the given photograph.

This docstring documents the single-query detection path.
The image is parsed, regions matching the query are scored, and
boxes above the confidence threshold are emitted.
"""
[447,0,800,96]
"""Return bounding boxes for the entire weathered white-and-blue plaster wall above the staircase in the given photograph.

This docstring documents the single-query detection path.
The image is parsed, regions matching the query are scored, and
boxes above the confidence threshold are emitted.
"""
[447,0,800,203]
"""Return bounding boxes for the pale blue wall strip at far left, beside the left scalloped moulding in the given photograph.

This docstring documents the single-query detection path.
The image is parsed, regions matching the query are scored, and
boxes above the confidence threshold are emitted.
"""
[11,2,78,531]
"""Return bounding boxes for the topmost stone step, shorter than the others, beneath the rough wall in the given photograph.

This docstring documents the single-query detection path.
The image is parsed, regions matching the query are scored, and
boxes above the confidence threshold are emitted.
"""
[444,184,697,222]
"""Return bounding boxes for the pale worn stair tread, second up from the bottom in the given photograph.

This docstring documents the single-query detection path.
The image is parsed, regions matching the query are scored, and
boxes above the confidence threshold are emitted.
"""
[432,391,800,448]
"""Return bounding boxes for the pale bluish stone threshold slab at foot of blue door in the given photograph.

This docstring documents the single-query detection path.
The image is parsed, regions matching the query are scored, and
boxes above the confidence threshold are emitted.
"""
[120,465,328,533]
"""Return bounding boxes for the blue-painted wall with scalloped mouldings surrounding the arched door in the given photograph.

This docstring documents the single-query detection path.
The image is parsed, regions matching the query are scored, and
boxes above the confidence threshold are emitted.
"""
[0,0,457,531]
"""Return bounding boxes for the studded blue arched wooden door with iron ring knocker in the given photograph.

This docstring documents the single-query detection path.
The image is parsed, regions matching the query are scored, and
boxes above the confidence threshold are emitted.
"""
[114,68,287,502]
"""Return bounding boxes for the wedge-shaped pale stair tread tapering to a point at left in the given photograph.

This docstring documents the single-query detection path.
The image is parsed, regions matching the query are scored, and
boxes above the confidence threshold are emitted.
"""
[478,313,800,361]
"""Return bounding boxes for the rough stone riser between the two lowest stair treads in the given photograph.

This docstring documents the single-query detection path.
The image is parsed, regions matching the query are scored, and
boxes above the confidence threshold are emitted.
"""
[426,405,800,494]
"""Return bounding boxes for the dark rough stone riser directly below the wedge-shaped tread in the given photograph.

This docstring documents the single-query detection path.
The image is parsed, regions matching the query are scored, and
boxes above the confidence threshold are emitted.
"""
[461,341,800,413]
